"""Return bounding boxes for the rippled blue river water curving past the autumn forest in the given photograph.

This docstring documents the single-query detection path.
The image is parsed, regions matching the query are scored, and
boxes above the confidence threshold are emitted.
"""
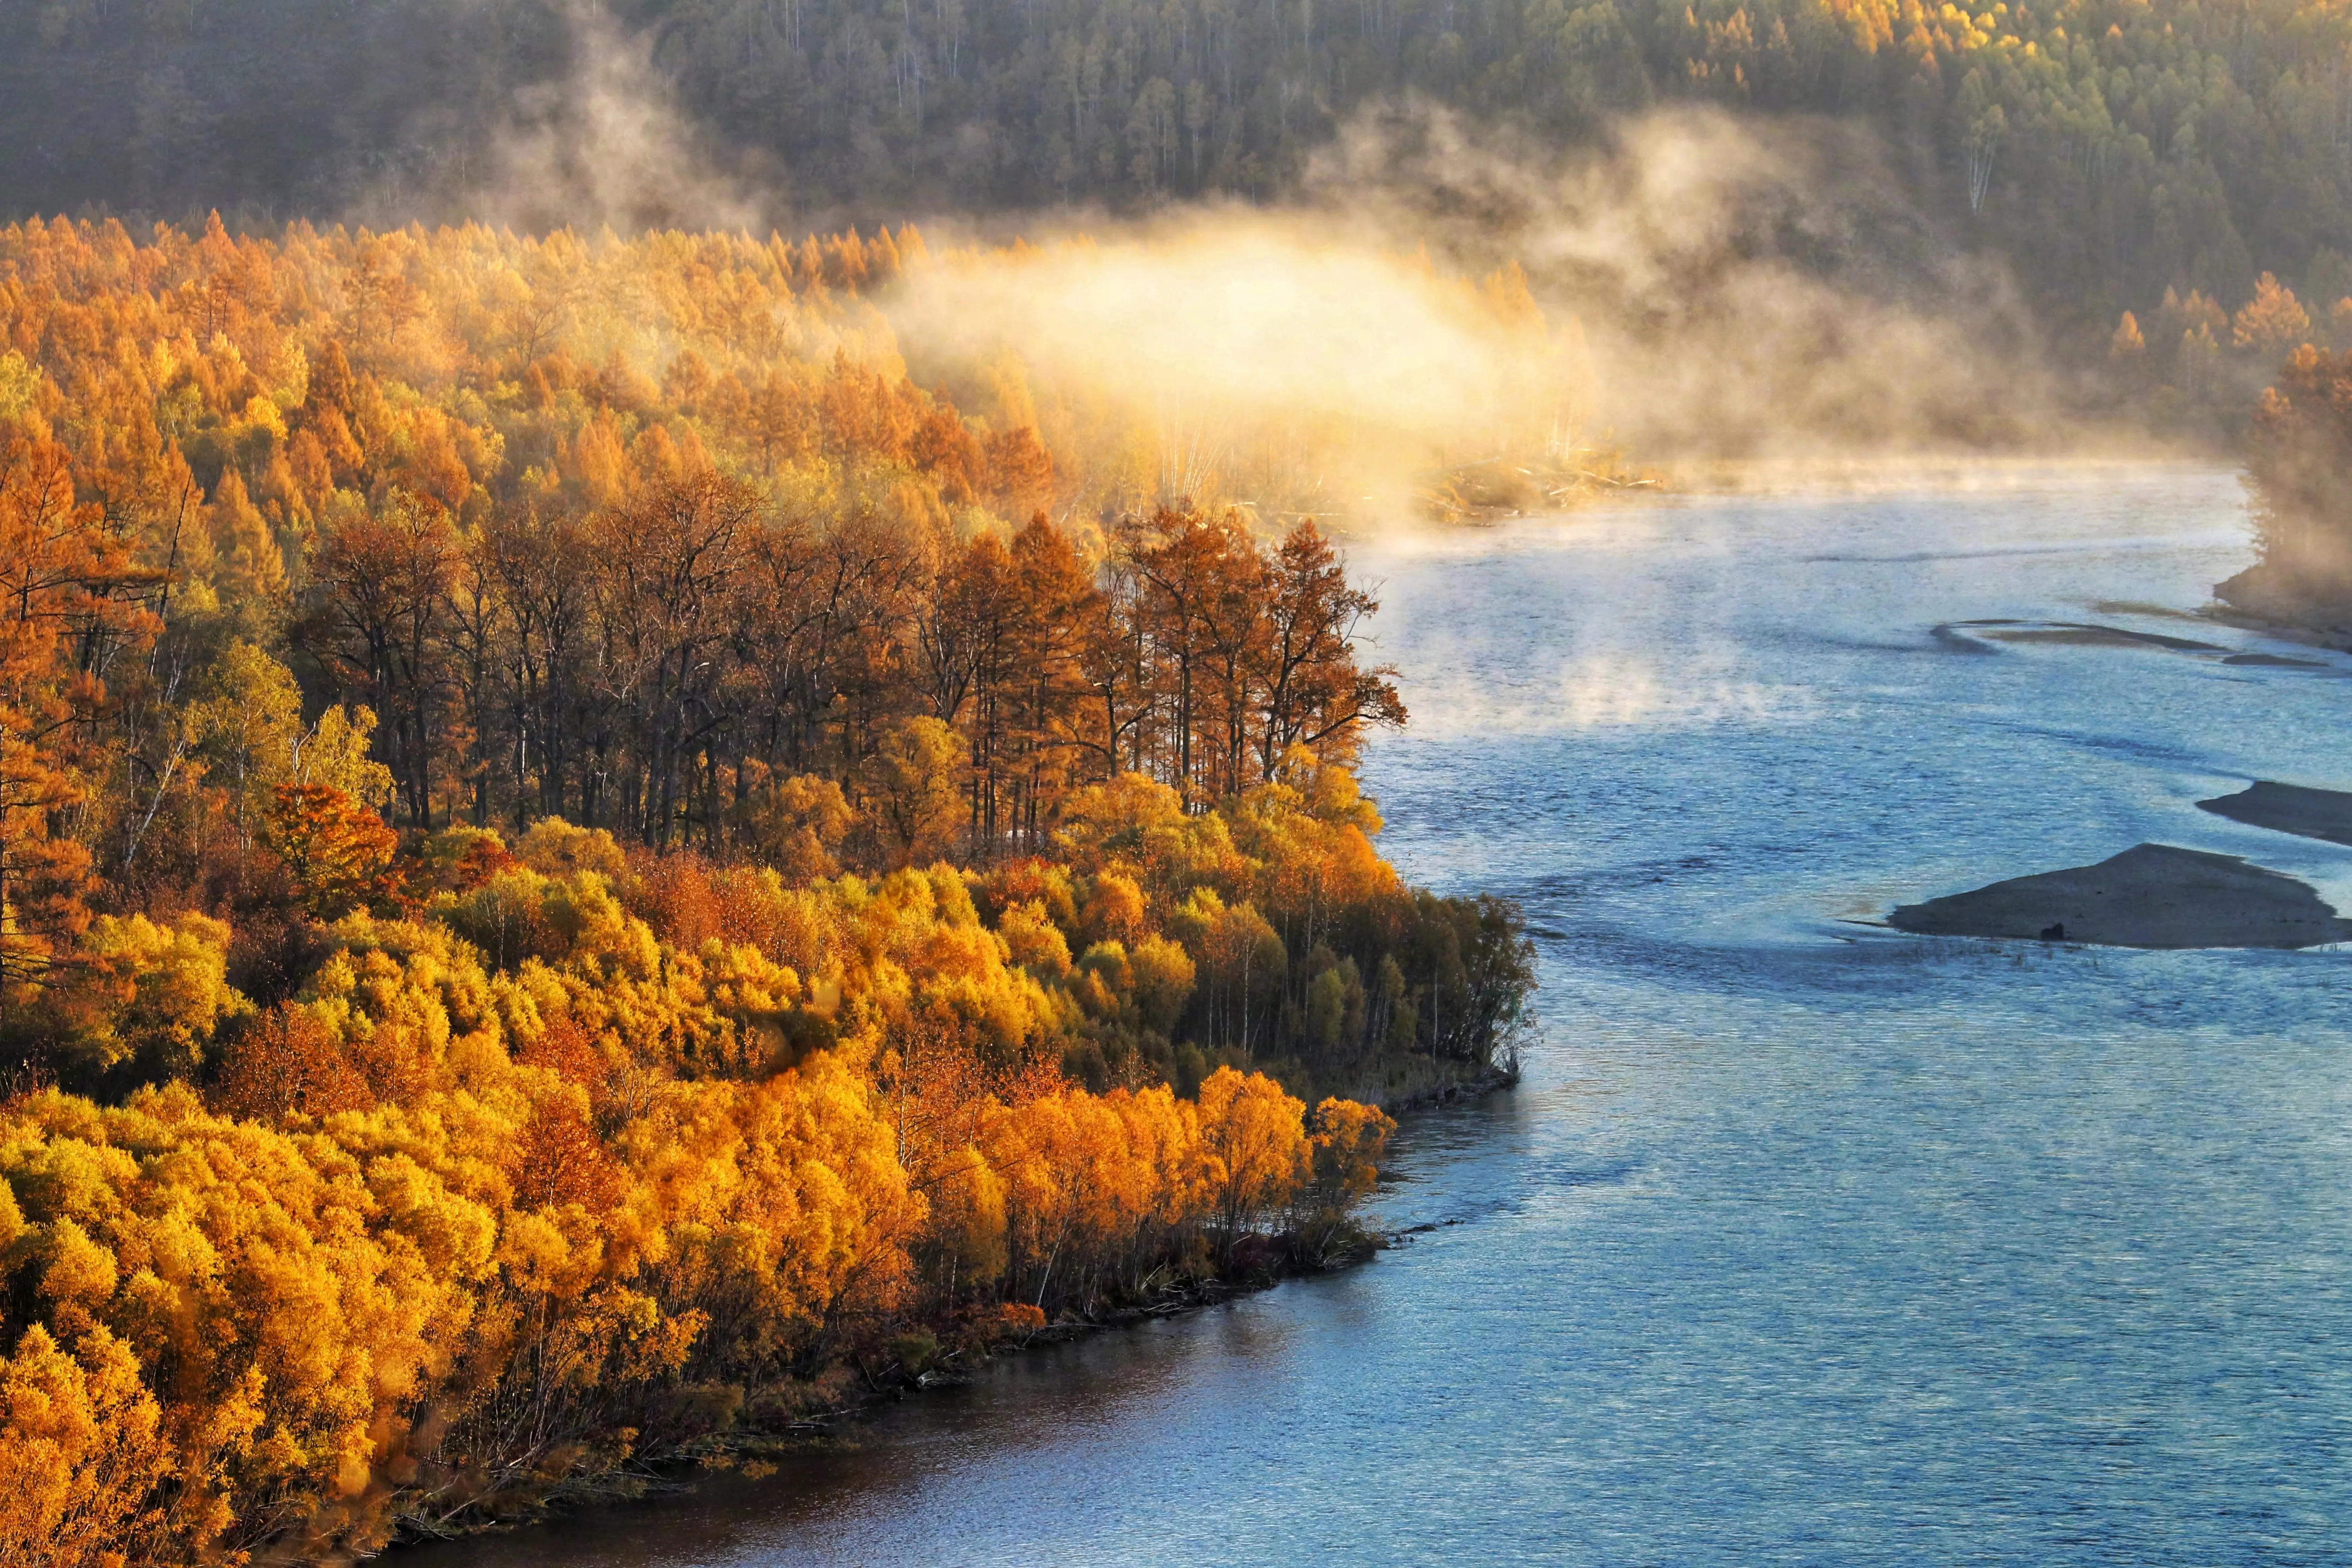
[423,468,2352,1568]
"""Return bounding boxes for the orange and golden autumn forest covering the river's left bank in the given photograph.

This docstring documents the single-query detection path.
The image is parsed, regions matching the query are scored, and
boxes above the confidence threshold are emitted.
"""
[0,219,1533,1566]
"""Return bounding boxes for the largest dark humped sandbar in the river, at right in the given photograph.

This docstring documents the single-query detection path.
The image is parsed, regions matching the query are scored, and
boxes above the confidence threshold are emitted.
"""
[1886,844,2352,947]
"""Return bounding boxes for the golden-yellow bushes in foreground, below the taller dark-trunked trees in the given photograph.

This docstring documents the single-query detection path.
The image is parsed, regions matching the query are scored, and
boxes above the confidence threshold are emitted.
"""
[0,757,1448,1563]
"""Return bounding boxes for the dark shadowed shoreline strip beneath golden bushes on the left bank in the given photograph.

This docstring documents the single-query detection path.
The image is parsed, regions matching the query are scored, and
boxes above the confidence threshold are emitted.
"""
[379,1063,1522,1561]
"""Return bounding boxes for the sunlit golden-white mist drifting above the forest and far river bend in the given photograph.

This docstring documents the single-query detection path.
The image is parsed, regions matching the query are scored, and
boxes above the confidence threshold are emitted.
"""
[414,9,2079,515]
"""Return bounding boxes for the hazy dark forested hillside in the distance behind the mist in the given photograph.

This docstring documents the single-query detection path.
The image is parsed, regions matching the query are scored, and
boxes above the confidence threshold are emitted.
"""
[0,0,2352,343]
